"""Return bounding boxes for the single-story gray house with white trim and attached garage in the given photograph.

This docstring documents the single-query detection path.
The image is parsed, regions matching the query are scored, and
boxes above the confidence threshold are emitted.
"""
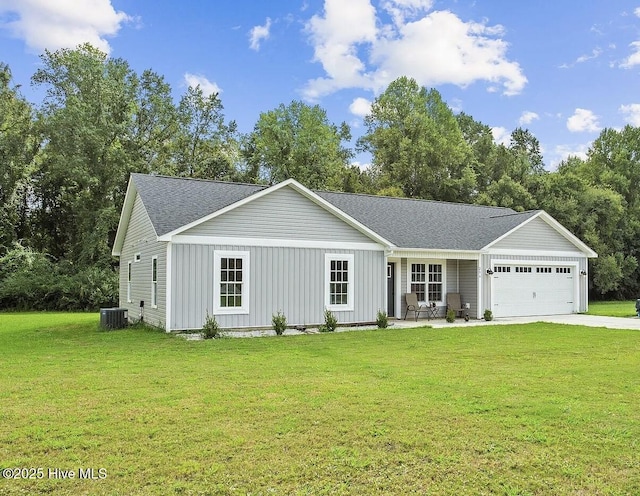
[113,174,597,331]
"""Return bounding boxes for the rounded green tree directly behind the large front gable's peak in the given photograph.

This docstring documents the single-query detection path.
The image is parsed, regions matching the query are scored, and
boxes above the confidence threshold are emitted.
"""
[244,101,352,189]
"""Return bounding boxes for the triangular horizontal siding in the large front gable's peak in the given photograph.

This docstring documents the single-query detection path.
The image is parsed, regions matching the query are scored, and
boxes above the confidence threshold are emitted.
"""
[182,187,372,243]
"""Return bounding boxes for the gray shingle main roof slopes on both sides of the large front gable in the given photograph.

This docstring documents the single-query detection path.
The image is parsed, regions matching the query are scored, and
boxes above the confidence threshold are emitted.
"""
[132,174,537,250]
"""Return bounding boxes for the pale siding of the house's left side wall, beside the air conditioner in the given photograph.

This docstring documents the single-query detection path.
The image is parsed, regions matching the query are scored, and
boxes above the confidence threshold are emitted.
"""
[120,197,167,327]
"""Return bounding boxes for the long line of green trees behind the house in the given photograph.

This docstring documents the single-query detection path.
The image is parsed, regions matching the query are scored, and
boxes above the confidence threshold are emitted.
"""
[0,44,640,309]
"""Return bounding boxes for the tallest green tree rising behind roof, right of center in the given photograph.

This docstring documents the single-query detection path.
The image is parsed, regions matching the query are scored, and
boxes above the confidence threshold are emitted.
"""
[358,77,476,201]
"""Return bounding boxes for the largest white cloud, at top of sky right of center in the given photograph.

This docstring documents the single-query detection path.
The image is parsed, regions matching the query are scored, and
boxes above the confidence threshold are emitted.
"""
[303,0,527,100]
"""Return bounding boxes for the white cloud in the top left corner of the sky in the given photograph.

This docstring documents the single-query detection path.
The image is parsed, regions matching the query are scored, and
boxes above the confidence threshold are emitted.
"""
[0,0,133,53]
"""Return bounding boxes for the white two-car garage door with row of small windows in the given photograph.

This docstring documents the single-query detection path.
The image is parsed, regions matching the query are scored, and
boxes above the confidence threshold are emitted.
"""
[491,264,576,317]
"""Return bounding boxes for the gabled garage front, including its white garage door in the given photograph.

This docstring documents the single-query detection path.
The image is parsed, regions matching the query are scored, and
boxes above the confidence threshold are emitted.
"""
[482,218,588,317]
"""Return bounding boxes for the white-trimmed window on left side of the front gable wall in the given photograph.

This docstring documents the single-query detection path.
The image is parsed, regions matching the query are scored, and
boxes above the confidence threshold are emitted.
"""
[213,251,249,314]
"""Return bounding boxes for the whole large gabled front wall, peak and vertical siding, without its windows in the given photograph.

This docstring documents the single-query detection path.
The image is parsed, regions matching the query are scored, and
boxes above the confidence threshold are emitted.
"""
[169,187,386,330]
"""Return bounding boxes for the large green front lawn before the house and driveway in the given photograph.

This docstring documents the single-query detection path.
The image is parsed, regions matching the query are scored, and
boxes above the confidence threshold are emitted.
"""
[0,314,640,495]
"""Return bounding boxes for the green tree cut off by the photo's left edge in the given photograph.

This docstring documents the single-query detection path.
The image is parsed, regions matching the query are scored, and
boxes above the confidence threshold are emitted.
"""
[0,63,38,255]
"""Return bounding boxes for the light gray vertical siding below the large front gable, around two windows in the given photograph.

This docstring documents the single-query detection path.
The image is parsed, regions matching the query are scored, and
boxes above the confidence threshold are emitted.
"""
[171,244,386,329]
